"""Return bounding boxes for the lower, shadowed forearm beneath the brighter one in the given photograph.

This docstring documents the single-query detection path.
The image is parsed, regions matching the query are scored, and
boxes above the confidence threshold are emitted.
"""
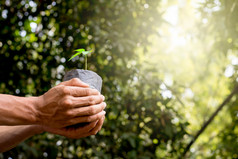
[0,125,43,152]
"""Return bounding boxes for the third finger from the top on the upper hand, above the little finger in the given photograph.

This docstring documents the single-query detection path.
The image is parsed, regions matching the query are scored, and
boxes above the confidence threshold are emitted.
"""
[70,102,106,117]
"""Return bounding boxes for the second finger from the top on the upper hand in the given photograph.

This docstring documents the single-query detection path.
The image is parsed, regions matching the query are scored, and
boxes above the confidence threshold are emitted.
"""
[72,95,105,107]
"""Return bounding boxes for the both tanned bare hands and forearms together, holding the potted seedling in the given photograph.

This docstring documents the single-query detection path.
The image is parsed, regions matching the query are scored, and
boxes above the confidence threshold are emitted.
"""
[0,78,106,152]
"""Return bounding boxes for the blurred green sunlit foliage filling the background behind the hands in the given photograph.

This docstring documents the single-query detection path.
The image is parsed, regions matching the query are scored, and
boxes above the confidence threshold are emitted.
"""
[0,0,238,159]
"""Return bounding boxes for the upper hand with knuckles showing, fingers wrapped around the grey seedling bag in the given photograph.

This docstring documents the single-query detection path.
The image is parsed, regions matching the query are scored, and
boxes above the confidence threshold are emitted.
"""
[35,78,106,128]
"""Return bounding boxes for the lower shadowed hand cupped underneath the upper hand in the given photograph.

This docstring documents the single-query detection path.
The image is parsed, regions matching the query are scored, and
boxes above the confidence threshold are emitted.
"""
[43,116,105,139]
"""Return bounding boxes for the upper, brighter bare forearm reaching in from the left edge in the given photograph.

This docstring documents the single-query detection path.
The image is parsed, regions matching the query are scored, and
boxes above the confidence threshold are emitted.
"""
[0,94,37,126]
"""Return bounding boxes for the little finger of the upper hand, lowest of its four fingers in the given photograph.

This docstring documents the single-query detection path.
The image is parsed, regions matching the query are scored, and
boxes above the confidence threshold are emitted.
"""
[70,111,106,125]
